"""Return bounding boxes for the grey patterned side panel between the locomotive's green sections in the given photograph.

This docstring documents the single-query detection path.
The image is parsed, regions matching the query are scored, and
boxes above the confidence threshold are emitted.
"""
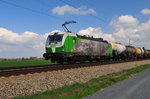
[72,39,110,55]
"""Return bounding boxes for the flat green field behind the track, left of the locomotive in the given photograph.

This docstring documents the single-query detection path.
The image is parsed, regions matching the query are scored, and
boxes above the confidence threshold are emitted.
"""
[0,59,52,68]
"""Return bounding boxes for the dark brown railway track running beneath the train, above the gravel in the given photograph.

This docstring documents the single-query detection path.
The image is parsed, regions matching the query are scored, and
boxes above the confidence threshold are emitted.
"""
[0,59,148,77]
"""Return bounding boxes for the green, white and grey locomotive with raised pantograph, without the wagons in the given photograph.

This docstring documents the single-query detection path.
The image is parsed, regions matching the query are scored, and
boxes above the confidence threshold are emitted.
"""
[43,21,113,63]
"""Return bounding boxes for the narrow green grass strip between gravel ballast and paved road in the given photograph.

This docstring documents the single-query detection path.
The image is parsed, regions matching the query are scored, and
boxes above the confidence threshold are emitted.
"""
[14,65,150,99]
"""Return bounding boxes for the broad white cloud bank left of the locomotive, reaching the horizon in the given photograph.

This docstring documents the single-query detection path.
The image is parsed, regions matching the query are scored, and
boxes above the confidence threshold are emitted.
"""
[0,28,56,58]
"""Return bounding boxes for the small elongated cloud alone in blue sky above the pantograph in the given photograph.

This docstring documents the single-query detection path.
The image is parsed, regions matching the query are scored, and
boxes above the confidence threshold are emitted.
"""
[52,5,96,15]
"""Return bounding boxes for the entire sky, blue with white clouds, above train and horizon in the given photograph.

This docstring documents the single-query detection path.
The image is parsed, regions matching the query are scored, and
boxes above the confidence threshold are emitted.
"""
[0,0,150,58]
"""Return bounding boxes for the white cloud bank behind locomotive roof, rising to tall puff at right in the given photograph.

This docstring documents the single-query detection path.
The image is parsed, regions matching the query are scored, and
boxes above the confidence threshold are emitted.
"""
[78,15,140,44]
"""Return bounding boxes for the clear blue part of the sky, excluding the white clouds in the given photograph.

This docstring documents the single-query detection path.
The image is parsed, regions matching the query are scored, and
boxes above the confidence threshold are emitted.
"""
[0,0,150,33]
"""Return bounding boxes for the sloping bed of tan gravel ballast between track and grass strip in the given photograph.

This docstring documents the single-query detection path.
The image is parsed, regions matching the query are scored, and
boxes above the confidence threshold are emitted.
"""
[0,60,150,99]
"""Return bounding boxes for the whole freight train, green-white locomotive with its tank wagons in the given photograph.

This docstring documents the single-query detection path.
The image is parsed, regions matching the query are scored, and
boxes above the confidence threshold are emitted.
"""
[43,21,150,64]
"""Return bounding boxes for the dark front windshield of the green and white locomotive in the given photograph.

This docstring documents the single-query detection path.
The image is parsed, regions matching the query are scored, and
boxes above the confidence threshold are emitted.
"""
[47,33,63,44]
